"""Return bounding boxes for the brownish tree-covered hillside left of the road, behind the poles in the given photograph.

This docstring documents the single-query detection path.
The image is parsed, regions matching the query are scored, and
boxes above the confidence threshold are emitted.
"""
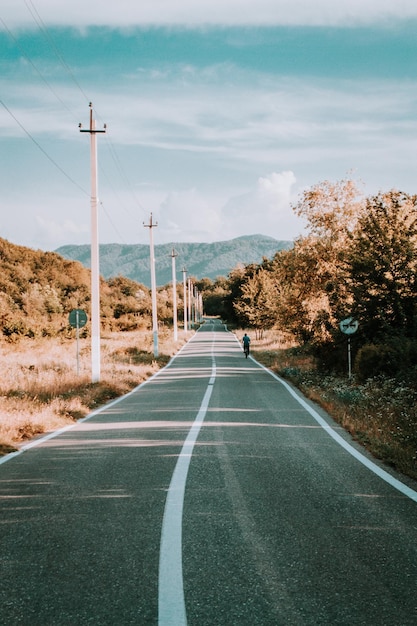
[0,239,182,341]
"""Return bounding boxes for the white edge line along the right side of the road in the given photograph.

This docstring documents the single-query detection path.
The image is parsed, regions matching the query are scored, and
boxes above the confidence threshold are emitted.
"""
[250,356,417,502]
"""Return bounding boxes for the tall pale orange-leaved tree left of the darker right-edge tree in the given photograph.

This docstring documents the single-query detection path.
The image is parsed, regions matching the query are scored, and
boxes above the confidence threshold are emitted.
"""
[274,180,364,343]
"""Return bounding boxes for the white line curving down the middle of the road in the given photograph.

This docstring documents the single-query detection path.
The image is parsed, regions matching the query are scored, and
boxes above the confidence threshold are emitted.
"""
[158,344,216,626]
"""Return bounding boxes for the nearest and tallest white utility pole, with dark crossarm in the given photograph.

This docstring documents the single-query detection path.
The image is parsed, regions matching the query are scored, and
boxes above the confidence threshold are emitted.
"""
[79,102,106,383]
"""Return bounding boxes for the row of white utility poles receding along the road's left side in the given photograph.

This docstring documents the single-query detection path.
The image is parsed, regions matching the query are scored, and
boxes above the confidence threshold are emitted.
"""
[77,102,203,383]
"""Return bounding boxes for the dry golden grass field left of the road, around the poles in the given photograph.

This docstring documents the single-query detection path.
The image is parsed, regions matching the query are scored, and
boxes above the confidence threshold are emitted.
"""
[0,331,190,454]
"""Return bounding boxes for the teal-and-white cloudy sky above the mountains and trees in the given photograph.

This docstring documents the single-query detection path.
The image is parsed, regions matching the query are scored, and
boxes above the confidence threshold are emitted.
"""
[0,0,417,250]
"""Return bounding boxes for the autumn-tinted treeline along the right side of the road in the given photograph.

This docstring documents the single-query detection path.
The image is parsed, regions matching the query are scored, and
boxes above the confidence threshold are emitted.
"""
[197,180,417,380]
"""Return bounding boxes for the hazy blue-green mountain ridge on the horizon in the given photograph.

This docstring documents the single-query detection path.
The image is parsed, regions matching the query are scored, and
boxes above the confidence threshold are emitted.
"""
[56,235,292,287]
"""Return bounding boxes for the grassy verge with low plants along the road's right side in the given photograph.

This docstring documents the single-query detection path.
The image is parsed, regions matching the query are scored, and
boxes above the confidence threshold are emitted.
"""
[252,331,417,479]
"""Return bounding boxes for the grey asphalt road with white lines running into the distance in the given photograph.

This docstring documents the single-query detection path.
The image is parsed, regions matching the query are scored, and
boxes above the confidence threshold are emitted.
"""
[0,323,417,626]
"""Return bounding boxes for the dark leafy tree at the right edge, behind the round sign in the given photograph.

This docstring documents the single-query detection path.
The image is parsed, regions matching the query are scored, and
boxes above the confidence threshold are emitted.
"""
[348,191,417,341]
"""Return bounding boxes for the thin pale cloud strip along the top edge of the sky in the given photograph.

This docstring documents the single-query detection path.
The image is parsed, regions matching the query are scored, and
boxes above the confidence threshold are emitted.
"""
[2,0,417,28]
